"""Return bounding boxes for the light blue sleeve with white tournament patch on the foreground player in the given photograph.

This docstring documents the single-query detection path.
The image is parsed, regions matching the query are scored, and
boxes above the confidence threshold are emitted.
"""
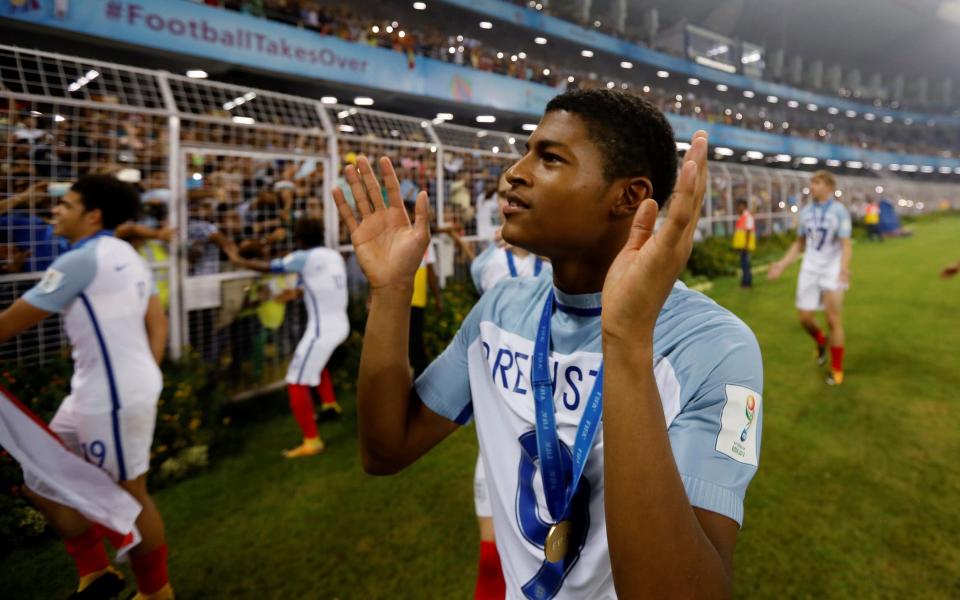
[668,326,763,525]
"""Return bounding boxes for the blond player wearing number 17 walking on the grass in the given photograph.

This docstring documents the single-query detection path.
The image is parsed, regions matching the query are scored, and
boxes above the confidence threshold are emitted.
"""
[767,171,853,385]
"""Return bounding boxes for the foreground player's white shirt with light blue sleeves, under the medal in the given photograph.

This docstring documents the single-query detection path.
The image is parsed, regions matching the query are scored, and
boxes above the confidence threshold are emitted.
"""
[416,278,763,600]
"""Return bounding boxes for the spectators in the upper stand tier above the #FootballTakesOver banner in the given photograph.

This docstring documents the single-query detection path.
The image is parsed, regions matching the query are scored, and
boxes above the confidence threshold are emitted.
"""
[197,0,960,156]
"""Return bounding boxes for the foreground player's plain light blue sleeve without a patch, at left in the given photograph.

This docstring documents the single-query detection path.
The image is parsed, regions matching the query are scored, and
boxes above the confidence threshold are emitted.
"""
[415,298,484,425]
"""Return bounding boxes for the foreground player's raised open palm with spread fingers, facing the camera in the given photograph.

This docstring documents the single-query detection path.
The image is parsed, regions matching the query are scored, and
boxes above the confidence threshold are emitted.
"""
[333,156,430,288]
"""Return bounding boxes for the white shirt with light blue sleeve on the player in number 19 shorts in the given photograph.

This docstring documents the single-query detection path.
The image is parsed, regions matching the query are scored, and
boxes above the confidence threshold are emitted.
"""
[23,231,163,413]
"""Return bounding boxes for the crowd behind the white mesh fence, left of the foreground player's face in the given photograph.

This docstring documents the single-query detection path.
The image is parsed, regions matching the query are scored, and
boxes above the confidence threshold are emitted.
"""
[0,96,492,275]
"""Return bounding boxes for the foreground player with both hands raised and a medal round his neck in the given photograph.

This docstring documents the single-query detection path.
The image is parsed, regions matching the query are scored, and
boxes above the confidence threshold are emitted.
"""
[334,90,762,599]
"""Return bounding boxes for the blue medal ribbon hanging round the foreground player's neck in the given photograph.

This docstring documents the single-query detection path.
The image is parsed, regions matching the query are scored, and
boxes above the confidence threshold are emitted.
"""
[531,291,603,522]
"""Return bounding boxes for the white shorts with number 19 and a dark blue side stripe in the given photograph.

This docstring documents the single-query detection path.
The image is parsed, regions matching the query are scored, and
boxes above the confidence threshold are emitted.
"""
[50,396,157,481]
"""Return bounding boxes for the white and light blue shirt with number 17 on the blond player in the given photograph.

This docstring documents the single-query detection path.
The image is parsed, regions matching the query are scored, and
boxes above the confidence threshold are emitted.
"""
[797,200,852,272]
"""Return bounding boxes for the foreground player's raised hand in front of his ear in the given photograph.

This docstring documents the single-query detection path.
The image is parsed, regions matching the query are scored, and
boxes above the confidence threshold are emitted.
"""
[602,131,707,339]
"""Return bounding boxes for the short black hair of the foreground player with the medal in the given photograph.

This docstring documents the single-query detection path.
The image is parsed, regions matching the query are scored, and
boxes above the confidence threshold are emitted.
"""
[546,90,678,206]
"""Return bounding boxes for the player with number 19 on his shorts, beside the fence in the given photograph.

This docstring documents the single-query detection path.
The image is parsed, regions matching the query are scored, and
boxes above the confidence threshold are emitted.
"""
[0,175,173,599]
